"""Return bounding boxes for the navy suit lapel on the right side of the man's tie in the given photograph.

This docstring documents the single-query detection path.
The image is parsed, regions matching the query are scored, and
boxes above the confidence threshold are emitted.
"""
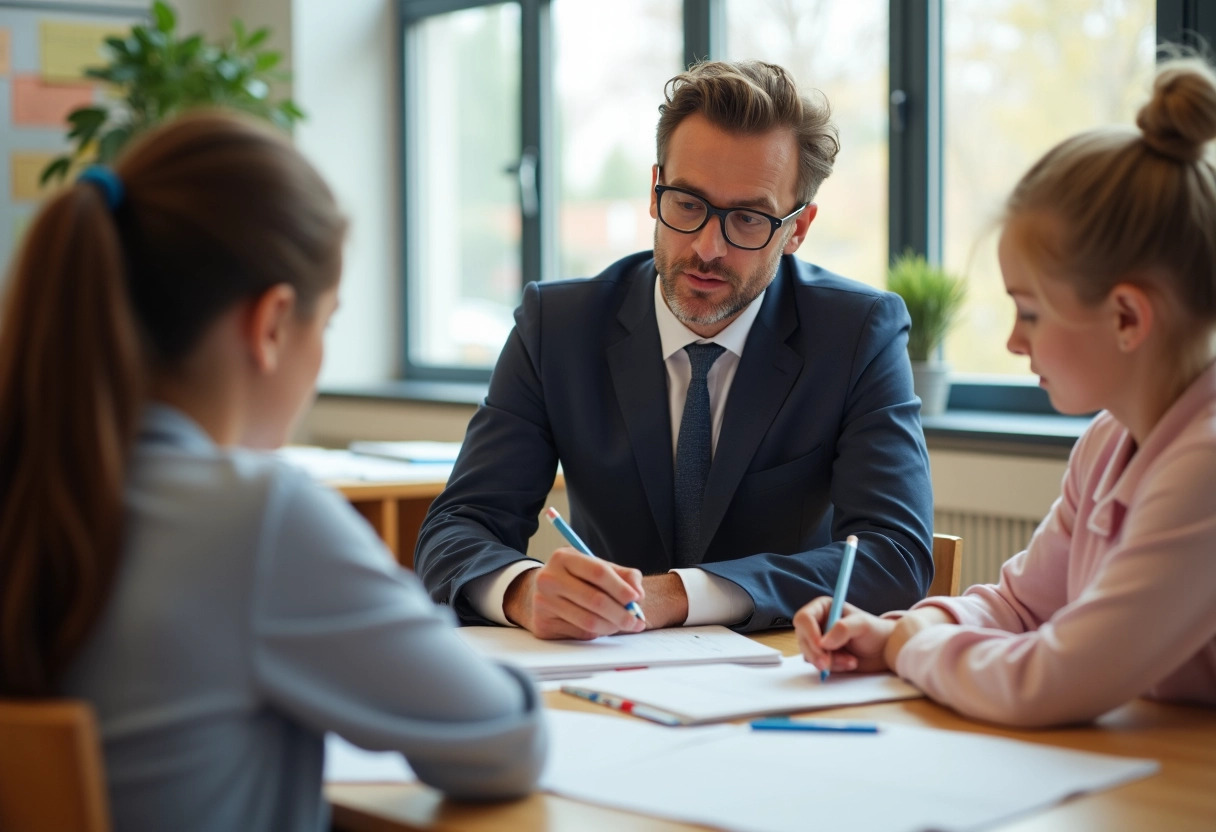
[700,257,803,557]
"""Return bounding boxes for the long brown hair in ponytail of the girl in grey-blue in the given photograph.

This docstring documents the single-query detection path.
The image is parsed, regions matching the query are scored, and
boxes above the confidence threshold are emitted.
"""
[0,113,345,696]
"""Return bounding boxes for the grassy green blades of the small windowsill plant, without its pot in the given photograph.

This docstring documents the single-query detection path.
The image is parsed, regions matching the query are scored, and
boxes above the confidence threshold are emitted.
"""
[886,252,967,361]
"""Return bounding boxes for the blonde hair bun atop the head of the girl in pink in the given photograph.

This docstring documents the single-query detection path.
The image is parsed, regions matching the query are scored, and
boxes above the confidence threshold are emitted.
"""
[1136,57,1216,162]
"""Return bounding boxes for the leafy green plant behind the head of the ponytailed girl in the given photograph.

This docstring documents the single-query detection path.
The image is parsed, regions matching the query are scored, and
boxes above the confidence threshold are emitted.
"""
[41,0,304,184]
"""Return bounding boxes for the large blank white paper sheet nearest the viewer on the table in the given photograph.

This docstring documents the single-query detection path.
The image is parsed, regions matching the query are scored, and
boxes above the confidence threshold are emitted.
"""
[544,714,1159,832]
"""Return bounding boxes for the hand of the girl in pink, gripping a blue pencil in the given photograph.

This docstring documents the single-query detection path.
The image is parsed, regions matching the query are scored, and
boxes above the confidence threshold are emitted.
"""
[794,595,895,673]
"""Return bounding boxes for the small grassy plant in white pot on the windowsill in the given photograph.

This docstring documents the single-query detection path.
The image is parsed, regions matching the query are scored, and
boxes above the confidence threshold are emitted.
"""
[886,246,967,416]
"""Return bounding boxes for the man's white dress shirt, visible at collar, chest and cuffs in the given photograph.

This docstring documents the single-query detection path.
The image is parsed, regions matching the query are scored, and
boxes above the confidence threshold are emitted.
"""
[465,279,764,626]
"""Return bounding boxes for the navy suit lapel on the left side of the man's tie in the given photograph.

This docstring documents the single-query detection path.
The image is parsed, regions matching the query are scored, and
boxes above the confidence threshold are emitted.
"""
[607,260,676,561]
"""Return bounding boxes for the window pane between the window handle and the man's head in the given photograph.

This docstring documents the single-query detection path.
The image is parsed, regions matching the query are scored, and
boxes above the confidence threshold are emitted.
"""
[552,0,683,277]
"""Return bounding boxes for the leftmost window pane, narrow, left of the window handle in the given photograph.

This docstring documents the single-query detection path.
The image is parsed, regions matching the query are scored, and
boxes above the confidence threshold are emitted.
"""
[411,4,520,367]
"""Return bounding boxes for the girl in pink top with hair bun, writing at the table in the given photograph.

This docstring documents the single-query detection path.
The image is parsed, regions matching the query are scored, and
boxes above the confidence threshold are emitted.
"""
[794,60,1216,726]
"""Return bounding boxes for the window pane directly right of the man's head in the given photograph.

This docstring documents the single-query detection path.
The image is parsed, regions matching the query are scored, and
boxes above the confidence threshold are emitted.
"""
[726,0,889,286]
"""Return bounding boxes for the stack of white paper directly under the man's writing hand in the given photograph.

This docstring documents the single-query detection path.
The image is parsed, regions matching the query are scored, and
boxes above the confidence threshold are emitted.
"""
[456,624,781,679]
